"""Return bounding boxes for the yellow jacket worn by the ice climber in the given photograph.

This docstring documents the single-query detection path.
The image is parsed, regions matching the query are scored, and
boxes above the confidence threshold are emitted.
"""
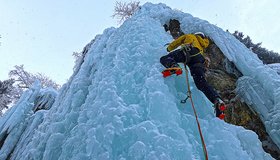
[167,34,209,53]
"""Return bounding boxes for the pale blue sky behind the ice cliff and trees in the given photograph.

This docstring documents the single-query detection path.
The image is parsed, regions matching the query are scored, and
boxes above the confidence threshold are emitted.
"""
[0,0,280,84]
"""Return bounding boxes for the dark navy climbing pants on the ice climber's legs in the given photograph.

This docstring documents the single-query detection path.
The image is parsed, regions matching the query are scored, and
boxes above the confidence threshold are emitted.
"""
[160,48,220,103]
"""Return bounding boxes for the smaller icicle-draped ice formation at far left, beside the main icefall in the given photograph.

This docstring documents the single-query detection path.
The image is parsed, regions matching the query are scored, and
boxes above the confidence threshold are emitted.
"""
[0,82,57,159]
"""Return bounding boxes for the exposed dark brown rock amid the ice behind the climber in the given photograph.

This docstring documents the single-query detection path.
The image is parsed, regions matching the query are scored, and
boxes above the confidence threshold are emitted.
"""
[164,19,280,159]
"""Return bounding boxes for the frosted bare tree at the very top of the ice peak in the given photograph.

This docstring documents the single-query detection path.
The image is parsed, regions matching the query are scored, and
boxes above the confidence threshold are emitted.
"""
[113,1,140,23]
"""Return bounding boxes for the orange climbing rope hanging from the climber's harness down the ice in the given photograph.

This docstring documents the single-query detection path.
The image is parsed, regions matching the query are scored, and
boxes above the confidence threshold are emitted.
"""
[181,63,208,160]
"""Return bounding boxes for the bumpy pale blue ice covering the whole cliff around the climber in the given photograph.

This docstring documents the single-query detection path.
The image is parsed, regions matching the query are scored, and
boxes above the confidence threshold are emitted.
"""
[0,3,280,160]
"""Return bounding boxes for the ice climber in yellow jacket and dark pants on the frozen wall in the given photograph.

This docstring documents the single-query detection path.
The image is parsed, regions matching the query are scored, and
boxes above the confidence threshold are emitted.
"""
[160,32,225,119]
